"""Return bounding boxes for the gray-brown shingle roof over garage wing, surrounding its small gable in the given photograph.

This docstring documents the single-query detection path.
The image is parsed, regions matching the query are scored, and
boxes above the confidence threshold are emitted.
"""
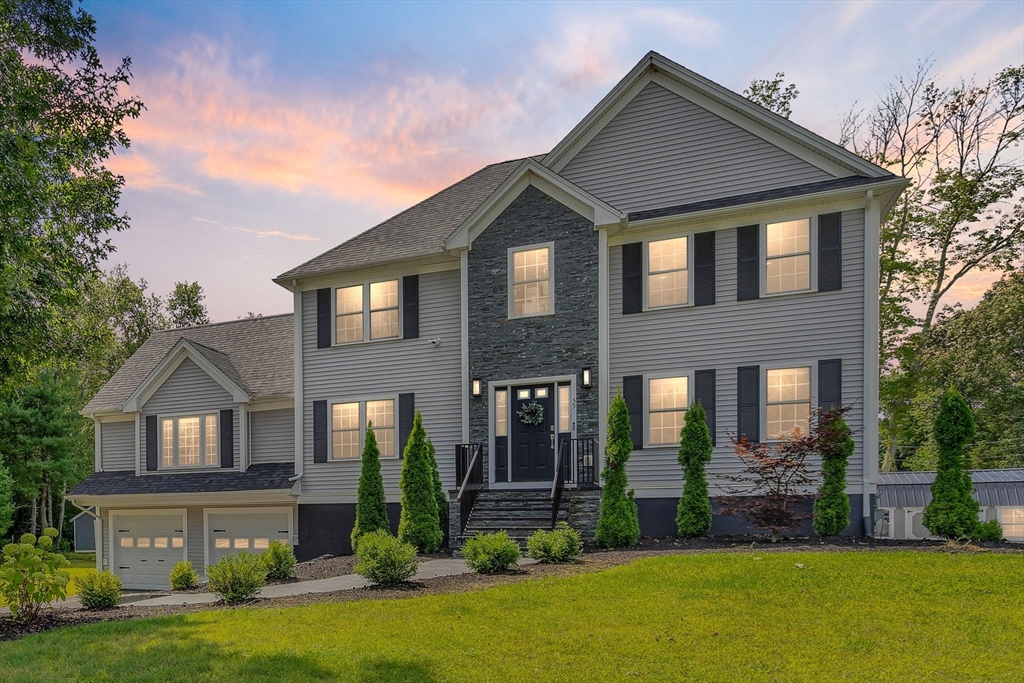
[83,313,295,413]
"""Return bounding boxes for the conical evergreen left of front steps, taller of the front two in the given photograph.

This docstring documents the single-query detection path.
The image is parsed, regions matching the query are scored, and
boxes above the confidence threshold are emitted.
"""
[398,413,443,553]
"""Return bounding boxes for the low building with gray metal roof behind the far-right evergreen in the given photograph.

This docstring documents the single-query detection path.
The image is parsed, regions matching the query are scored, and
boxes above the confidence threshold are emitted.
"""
[876,468,1024,543]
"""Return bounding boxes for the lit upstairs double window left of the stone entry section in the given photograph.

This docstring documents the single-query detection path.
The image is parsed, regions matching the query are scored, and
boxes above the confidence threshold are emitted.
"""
[334,280,398,344]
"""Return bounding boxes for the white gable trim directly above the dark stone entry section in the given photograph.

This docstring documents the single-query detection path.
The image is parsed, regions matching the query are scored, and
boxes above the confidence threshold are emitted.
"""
[444,159,626,251]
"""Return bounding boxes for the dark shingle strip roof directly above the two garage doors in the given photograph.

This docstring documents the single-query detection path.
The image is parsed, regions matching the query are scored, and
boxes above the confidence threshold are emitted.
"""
[68,463,295,496]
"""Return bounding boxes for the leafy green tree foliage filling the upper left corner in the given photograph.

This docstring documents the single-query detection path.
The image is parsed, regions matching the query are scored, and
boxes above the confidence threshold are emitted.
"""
[0,0,142,377]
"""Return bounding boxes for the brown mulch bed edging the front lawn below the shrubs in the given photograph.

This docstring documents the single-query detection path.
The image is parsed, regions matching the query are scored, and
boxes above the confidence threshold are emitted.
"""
[0,536,1024,641]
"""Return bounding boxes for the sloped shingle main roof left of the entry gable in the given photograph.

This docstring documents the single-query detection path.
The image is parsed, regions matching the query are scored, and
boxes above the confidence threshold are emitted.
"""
[276,159,524,281]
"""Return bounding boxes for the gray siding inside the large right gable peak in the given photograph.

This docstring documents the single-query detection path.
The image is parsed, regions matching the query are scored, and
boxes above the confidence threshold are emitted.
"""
[561,83,833,212]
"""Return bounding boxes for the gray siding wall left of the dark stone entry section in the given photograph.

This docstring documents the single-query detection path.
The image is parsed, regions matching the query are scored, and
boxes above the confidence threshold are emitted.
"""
[301,270,464,502]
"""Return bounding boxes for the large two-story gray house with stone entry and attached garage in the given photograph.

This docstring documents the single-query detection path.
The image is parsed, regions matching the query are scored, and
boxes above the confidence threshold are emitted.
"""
[69,52,906,586]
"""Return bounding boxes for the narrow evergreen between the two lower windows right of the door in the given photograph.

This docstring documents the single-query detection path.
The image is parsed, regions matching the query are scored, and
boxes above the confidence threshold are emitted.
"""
[676,401,712,539]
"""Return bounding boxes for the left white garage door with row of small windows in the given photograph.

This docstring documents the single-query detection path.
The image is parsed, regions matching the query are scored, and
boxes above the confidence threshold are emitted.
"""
[113,512,185,589]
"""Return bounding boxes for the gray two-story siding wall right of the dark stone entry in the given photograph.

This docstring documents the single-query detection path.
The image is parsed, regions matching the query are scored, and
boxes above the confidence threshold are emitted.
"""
[605,210,864,497]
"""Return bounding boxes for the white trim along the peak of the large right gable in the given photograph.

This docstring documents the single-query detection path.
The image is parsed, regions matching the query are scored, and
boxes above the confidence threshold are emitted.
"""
[542,51,891,177]
